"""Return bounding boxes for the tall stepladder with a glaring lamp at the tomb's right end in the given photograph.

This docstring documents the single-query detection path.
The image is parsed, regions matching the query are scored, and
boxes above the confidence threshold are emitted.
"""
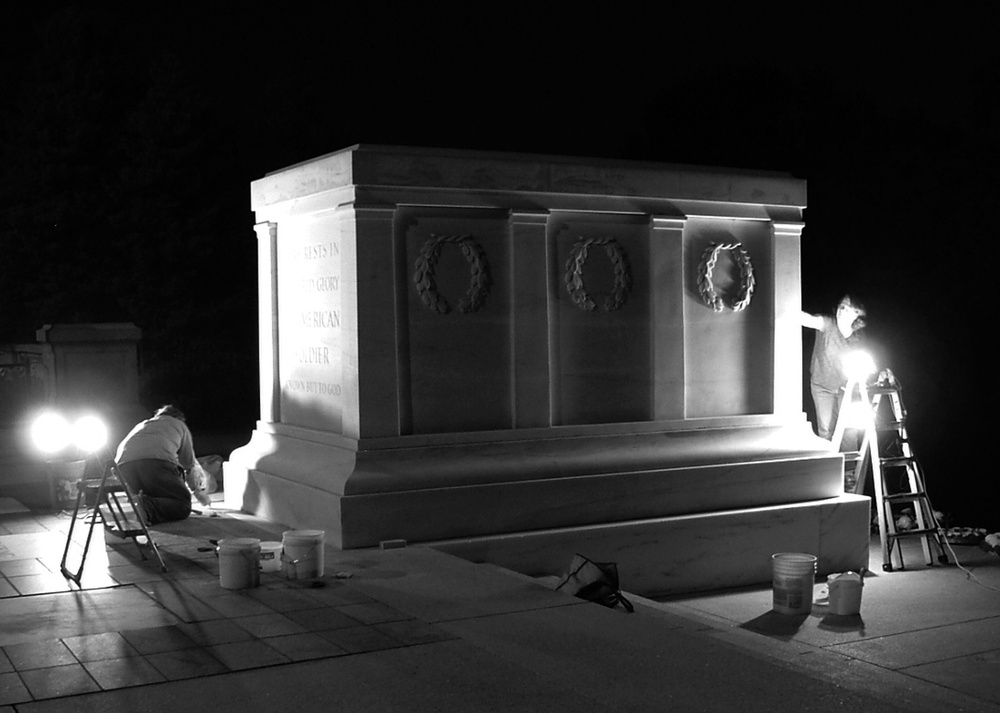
[833,369,948,572]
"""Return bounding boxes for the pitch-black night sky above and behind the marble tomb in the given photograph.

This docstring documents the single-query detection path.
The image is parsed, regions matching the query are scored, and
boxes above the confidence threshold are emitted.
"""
[0,1,1000,526]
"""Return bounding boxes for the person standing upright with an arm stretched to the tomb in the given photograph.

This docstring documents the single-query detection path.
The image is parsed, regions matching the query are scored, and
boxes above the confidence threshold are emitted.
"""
[802,295,865,441]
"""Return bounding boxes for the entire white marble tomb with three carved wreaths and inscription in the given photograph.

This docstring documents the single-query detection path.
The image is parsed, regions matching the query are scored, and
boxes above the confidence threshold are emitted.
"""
[225,145,868,594]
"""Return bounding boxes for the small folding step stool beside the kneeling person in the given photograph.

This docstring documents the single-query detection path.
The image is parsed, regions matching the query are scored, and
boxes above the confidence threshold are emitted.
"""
[59,461,167,586]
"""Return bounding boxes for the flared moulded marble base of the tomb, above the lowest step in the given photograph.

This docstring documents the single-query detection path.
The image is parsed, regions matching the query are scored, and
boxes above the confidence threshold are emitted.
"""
[225,424,844,549]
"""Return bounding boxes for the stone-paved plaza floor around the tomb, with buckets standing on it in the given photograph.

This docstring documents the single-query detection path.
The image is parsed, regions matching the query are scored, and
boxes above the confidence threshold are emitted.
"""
[0,501,1000,713]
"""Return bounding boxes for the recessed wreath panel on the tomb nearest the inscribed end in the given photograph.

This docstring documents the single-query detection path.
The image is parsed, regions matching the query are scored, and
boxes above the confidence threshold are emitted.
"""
[397,208,512,433]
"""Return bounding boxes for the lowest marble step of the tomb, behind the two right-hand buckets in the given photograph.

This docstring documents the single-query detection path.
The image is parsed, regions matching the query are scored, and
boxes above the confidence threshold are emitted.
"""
[422,494,870,597]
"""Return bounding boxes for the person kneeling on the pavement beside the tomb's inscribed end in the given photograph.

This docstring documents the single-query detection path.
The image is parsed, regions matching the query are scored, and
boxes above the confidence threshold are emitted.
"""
[115,404,212,525]
